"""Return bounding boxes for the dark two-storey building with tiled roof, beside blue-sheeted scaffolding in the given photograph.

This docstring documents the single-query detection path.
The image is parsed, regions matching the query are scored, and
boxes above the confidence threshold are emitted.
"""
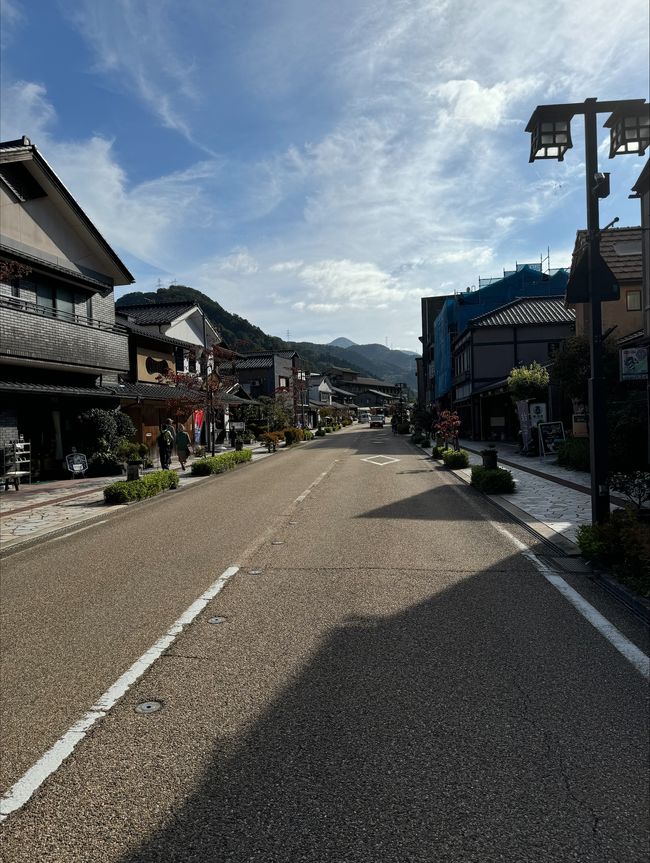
[452,294,575,440]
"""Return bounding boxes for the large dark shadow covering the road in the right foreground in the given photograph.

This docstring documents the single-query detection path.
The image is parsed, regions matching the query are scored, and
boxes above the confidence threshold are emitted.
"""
[122,557,647,863]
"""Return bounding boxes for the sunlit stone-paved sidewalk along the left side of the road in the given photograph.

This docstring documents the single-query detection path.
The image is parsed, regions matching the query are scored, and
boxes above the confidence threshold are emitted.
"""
[0,444,268,552]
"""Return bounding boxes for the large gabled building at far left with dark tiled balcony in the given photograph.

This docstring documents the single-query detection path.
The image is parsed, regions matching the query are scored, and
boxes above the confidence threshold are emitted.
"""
[0,137,133,477]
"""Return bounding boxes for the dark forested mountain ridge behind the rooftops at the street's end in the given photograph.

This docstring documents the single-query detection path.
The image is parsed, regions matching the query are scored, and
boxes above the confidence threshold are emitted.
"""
[115,285,417,390]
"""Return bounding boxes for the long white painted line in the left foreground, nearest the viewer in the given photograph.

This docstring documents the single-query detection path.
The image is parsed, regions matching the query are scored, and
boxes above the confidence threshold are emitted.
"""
[0,566,239,822]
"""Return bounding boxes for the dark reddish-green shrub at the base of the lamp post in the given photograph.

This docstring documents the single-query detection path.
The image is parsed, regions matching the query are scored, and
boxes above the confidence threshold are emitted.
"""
[576,507,650,598]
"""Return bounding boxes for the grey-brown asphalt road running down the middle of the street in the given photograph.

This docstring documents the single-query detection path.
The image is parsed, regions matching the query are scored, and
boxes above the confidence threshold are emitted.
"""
[0,428,649,863]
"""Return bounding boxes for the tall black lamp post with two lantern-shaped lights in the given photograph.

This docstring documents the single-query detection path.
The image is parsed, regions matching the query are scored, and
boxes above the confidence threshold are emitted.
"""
[526,99,650,524]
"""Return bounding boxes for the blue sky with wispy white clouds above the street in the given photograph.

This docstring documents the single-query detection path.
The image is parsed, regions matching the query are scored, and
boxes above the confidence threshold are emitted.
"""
[0,0,649,351]
